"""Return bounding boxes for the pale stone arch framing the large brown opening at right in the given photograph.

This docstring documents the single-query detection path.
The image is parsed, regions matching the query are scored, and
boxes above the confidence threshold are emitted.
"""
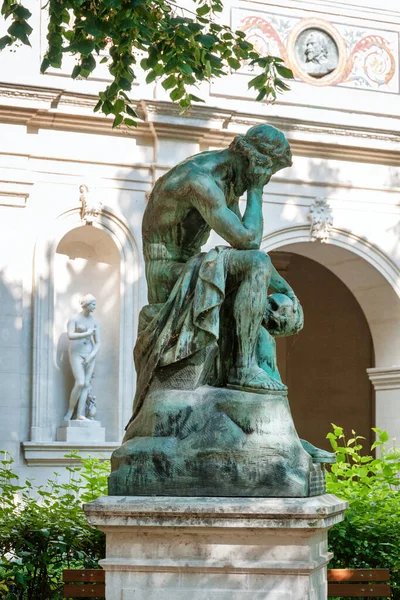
[263,226,400,446]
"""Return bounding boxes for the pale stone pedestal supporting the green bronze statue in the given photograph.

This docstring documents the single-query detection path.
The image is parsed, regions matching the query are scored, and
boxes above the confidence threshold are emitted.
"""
[84,495,347,600]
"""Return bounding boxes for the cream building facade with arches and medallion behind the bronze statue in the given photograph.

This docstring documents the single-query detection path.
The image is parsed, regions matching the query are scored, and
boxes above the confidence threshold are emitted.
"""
[0,0,400,481]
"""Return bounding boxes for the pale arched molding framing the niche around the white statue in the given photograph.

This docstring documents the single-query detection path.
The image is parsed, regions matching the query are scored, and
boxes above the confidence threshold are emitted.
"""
[31,208,141,442]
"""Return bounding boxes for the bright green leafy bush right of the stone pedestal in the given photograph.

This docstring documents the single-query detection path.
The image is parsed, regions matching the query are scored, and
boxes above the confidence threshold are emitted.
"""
[327,425,400,600]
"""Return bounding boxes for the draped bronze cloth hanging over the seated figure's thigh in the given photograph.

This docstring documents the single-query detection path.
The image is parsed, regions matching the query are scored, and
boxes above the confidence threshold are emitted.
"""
[128,246,232,425]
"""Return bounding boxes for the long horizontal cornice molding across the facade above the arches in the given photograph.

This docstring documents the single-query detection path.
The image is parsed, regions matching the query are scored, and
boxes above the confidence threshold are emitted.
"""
[0,83,400,166]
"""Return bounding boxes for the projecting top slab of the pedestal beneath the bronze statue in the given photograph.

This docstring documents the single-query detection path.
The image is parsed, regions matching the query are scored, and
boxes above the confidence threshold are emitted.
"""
[84,494,347,531]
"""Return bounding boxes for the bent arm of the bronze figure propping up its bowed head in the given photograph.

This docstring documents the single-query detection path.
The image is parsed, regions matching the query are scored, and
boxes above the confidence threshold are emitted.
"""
[191,178,262,250]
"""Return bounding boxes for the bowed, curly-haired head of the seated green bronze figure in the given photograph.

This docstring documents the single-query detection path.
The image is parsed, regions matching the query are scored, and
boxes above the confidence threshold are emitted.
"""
[229,125,292,193]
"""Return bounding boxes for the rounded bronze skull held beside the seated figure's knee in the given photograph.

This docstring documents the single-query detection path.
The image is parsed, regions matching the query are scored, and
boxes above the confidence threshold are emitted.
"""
[263,294,304,337]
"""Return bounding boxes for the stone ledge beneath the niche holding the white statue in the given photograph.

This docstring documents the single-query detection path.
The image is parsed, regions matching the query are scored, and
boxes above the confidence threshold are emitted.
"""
[21,442,119,467]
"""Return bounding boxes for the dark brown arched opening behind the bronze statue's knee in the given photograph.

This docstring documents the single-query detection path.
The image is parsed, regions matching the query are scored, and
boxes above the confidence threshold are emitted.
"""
[270,252,374,449]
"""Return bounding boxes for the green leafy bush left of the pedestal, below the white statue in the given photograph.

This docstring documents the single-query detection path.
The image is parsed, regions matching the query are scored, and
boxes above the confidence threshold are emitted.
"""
[0,454,109,600]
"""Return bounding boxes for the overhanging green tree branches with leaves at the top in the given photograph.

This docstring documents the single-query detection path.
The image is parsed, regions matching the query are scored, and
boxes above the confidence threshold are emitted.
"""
[0,0,293,127]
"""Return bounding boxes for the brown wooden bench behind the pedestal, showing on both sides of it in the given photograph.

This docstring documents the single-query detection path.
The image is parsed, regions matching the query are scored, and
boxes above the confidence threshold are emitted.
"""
[63,569,390,598]
